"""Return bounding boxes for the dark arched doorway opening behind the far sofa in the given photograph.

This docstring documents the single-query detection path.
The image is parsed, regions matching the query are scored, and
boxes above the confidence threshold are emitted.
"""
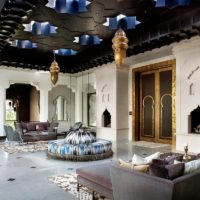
[6,83,40,125]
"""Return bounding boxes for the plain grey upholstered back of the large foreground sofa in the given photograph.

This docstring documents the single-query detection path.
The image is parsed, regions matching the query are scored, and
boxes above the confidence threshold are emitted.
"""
[110,165,200,200]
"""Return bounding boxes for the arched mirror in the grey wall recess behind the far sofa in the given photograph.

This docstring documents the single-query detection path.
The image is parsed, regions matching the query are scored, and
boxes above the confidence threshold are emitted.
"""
[53,96,68,121]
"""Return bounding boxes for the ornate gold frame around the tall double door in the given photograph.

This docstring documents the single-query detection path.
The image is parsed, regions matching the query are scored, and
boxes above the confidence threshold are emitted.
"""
[132,60,176,147]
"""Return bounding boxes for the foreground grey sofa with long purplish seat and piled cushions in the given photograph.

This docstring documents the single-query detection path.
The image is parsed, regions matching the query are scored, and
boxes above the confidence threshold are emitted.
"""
[76,153,200,200]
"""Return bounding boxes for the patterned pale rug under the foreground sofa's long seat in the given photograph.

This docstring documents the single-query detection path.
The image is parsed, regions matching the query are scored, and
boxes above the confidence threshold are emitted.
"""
[49,172,108,200]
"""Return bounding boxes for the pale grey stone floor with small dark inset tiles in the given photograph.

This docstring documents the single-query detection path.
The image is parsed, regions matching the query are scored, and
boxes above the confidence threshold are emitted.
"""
[0,142,171,200]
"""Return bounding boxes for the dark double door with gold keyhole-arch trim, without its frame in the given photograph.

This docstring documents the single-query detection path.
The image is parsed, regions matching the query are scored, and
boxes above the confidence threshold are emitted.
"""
[136,67,173,143]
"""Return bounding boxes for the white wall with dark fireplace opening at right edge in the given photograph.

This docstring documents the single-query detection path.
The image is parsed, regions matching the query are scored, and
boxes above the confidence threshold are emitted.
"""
[173,37,200,153]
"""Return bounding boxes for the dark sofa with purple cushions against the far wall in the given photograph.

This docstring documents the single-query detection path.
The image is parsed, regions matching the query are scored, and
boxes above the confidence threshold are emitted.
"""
[15,122,58,142]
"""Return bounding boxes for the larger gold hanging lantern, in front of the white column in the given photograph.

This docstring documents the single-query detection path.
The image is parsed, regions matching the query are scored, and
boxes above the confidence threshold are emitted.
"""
[112,29,128,65]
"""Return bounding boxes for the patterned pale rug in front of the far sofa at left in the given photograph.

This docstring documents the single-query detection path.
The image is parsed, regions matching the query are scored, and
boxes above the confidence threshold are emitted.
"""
[0,141,48,154]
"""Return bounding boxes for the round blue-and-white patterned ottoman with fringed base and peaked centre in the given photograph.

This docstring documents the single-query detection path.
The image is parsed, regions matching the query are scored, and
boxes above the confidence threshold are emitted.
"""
[48,122,113,161]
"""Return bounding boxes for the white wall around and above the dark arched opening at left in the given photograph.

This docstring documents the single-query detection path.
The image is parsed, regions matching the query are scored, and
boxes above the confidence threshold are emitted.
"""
[0,66,76,136]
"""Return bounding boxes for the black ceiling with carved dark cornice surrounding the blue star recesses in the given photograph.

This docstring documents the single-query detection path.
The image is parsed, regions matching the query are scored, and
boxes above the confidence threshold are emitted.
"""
[0,0,200,73]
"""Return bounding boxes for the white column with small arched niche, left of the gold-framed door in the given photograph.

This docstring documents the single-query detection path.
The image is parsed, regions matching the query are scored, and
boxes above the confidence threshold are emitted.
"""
[96,63,128,141]
